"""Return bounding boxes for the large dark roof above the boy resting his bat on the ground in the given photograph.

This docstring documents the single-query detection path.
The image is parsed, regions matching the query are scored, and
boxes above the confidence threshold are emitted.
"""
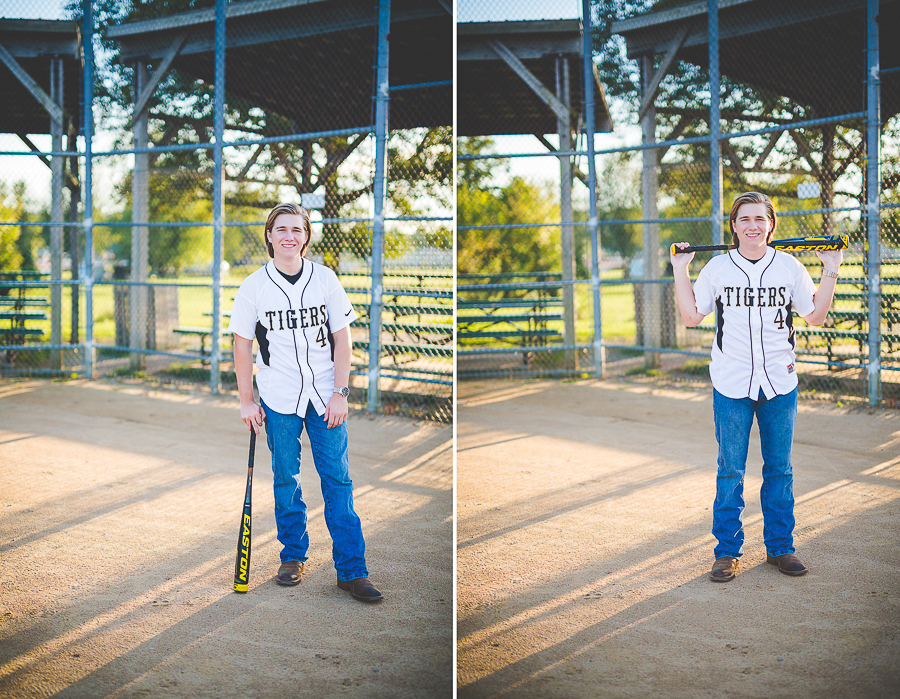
[107,0,453,132]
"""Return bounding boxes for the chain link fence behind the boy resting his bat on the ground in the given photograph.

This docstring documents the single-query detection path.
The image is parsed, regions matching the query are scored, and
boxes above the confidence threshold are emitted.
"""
[0,0,453,420]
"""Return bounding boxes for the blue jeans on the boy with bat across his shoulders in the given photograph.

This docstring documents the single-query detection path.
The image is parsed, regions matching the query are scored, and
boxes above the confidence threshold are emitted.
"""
[712,389,797,558]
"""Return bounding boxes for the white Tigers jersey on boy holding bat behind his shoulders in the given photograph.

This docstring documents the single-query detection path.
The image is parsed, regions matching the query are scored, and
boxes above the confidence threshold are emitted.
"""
[694,248,816,400]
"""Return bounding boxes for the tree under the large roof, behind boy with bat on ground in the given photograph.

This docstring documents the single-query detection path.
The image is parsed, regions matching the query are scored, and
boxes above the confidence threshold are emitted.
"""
[68,0,452,269]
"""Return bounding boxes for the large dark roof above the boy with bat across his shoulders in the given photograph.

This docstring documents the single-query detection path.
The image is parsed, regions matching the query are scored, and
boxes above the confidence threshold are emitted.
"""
[612,0,900,120]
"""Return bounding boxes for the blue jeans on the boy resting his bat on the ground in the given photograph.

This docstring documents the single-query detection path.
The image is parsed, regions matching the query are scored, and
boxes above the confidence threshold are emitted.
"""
[262,403,369,580]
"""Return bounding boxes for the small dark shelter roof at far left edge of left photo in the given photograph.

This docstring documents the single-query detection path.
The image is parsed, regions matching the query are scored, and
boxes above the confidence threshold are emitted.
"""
[0,19,82,134]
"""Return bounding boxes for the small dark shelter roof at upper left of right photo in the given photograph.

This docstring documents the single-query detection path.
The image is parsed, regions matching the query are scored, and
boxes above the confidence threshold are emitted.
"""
[456,19,612,136]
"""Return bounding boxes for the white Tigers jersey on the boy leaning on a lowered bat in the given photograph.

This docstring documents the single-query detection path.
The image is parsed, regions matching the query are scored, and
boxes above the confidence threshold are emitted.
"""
[228,259,357,416]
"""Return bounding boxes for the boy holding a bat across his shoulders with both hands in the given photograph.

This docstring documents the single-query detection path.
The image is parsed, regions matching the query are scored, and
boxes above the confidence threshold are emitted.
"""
[671,192,843,582]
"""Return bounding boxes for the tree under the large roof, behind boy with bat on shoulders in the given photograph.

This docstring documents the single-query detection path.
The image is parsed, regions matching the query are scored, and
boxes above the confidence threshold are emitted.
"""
[593,0,865,239]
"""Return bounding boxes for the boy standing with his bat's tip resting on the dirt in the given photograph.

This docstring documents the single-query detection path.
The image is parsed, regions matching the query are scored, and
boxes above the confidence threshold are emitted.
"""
[228,204,382,602]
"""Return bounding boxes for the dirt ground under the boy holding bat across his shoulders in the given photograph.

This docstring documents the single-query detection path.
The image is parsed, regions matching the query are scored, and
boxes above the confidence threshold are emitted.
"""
[457,380,900,699]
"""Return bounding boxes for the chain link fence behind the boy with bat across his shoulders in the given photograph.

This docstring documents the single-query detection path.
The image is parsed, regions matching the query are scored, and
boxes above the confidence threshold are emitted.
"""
[458,0,900,406]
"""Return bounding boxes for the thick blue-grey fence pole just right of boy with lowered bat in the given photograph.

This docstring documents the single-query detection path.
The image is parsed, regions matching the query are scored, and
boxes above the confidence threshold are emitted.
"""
[366,0,391,413]
